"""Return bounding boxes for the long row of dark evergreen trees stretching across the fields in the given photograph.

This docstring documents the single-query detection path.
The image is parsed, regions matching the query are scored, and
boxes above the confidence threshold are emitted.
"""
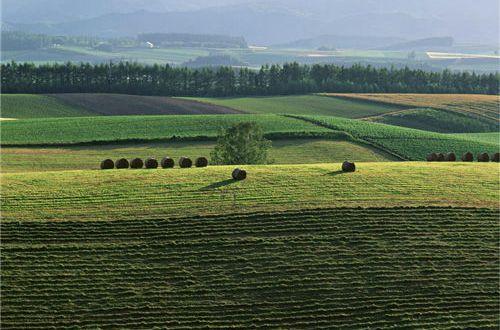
[1,62,500,96]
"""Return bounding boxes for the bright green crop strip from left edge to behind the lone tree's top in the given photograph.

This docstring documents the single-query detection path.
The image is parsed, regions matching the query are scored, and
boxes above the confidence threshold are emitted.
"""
[1,115,331,146]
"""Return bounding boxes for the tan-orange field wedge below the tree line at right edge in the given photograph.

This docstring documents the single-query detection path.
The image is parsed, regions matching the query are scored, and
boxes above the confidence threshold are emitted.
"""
[328,94,500,124]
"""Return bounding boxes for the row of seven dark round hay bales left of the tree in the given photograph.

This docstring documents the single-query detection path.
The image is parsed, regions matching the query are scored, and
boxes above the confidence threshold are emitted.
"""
[101,157,208,170]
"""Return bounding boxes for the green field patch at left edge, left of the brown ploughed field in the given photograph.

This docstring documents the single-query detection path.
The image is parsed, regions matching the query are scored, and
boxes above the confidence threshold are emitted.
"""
[0,94,92,118]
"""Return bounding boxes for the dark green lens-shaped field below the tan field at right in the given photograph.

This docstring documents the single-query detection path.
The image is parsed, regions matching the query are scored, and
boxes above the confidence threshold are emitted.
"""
[365,108,500,133]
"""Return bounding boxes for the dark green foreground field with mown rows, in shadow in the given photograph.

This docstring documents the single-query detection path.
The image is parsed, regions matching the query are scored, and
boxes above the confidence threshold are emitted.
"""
[1,208,500,329]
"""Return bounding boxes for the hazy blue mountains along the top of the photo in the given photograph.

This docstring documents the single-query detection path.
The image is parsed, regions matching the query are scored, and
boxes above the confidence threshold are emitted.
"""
[2,0,500,45]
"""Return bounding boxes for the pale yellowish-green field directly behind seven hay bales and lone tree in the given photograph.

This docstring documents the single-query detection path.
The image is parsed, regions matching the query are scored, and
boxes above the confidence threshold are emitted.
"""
[0,139,395,173]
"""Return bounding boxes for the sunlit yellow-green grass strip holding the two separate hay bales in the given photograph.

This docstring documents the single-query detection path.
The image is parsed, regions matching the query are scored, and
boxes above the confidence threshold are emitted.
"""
[1,162,500,221]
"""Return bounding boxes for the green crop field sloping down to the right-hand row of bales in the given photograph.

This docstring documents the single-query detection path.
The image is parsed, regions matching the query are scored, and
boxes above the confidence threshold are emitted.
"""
[301,116,500,160]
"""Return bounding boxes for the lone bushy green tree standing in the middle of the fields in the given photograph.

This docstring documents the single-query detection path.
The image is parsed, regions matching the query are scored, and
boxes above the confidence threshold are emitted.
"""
[211,122,271,165]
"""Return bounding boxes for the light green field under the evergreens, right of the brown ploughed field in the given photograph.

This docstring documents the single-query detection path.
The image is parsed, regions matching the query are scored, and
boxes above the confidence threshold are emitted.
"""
[188,95,403,118]
